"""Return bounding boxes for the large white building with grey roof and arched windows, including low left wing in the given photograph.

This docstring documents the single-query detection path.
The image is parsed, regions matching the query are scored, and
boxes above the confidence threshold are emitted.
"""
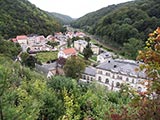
[82,59,148,92]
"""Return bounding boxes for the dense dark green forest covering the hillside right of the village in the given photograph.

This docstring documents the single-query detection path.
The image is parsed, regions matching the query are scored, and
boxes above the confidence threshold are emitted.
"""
[72,0,160,59]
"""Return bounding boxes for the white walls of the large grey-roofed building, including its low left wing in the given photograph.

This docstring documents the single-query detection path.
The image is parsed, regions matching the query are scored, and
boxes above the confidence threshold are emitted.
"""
[82,69,146,92]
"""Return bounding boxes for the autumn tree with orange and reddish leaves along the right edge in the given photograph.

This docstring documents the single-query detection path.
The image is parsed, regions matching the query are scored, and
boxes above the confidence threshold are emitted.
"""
[131,27,160,120]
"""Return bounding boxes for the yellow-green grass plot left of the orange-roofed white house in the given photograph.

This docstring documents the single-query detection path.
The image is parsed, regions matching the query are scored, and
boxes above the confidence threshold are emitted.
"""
[36,51,58,63]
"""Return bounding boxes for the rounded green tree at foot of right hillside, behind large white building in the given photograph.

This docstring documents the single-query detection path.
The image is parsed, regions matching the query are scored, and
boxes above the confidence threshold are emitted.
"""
[122,38,143,59]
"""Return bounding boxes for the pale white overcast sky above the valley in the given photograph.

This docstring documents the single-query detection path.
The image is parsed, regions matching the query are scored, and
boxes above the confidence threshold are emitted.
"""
[29,0,131,18]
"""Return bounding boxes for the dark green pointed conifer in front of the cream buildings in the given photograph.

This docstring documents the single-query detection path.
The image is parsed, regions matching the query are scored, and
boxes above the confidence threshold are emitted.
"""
[83,42,93,60]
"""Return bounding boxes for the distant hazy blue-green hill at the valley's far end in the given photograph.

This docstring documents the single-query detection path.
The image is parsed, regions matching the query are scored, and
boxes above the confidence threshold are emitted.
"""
[48,12,74,24]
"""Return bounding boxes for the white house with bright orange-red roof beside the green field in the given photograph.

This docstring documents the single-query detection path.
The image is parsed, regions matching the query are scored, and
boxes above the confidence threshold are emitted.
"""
[58,48,77,59]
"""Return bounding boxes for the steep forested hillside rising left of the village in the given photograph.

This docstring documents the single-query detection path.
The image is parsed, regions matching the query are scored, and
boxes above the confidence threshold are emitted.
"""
[0,0,62,38]
